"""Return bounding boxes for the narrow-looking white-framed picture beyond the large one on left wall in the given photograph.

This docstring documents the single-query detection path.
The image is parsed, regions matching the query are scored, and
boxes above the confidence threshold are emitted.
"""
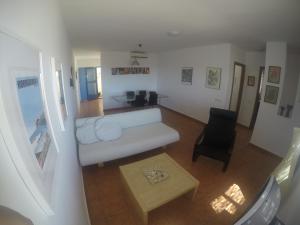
[51,57,68,130]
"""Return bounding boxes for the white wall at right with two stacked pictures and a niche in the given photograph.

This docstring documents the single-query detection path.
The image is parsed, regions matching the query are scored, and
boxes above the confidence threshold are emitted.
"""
[251,42,300,156]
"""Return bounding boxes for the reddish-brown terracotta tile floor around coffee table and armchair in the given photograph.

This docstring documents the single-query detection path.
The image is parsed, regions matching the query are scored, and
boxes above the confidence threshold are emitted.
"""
[83,102,280,225]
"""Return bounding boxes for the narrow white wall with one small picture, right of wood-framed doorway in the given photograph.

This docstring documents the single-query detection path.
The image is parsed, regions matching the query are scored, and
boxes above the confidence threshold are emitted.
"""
[238,52,265,127]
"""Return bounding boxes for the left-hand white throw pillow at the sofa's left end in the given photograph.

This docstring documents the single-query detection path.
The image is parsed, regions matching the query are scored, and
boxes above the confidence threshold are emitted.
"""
[76,123,99,144]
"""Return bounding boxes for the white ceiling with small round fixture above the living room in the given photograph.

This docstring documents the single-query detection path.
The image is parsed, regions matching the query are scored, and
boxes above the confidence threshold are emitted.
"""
[60,0,300,52]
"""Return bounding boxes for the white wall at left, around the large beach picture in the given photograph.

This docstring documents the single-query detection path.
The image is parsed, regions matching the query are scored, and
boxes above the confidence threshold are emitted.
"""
[0,0,88,225]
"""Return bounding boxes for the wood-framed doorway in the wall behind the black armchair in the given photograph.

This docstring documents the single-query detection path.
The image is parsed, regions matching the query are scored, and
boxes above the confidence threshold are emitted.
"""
[229,62,246,115]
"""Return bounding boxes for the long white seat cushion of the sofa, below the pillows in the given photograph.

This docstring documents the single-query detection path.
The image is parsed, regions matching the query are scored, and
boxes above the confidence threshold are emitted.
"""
[79,122,179,166]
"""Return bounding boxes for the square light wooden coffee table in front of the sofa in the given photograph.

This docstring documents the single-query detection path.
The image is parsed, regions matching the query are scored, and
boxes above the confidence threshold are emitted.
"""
[120,153,199,224]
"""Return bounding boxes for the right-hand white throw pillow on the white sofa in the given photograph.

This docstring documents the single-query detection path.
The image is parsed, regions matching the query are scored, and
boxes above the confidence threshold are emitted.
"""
[95,120,122,141]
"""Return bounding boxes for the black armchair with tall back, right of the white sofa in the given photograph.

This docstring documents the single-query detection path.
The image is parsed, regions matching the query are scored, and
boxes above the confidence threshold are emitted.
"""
[193,108,237,171]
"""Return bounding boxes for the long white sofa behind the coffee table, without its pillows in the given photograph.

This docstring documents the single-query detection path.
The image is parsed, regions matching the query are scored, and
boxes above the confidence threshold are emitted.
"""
[76,108,179,166]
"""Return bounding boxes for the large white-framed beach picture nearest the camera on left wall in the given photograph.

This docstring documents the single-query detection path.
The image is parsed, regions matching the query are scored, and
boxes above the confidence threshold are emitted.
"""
[0,32,58,216]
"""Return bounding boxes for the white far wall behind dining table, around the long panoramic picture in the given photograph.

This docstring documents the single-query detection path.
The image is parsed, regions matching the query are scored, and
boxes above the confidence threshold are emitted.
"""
[101,51,157,109]
